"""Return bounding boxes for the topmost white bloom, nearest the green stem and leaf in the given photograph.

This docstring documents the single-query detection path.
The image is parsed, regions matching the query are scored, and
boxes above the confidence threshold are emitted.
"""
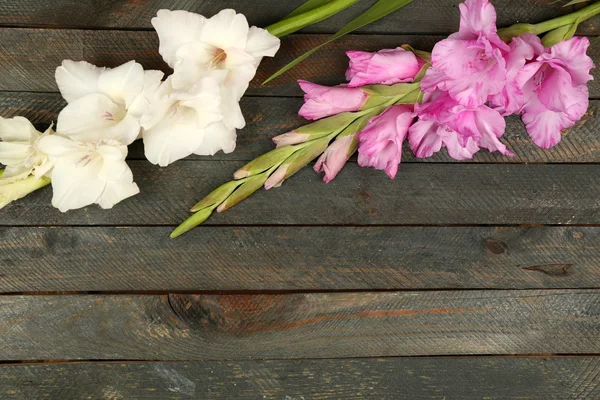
[152,9,280,129]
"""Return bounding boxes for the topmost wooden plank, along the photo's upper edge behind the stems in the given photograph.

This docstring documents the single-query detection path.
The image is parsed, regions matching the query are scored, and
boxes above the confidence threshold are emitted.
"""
[0,0,597,34]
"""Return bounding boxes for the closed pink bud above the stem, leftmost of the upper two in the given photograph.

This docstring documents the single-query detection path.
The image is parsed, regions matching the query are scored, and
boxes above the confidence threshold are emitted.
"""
[298,80,369,120]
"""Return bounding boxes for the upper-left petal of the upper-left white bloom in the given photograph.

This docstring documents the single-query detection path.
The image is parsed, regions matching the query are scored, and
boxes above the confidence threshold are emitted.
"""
[55,60,105,103]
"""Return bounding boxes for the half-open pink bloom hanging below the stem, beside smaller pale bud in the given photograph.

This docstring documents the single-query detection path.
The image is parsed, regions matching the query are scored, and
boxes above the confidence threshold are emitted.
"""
[358,105,414,179]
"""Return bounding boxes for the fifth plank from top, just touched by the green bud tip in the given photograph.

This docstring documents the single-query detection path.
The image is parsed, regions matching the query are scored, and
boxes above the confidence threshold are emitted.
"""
[0,227,600,293]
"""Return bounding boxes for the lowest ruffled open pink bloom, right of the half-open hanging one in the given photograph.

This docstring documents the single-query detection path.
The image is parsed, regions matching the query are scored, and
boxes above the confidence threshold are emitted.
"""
[408,91,514,160]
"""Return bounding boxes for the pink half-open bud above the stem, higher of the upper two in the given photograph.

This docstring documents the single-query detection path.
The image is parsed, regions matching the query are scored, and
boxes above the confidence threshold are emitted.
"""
[346,47,425,87]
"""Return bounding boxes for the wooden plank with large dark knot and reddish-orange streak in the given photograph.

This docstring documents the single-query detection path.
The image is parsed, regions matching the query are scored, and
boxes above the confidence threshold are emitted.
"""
[0,290,600,360]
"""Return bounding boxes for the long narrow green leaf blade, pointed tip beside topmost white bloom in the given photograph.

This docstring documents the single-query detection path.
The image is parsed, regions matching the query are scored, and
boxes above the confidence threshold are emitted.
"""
[263,0,412,85]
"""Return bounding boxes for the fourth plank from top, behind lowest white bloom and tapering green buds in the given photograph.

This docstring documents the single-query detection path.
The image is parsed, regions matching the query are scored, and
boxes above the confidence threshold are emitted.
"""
[0,161,600,226]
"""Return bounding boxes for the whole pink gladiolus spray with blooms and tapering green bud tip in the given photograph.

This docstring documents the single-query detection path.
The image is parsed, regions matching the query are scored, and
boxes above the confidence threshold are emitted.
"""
[171,0,600,237]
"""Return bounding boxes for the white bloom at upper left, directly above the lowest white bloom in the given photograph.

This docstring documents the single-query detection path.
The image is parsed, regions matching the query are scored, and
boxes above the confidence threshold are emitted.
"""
[56,60,163,145]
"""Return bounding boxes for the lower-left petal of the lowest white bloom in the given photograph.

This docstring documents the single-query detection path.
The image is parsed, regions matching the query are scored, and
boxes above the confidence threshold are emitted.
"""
[52,151,106,212]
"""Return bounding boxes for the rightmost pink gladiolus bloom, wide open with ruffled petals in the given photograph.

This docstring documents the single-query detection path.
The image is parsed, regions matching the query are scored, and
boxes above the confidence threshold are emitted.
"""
[517,37,594,149]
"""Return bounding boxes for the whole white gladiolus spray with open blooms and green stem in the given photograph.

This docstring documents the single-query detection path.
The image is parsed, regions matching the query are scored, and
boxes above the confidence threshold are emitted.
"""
[0,0,411,212]
